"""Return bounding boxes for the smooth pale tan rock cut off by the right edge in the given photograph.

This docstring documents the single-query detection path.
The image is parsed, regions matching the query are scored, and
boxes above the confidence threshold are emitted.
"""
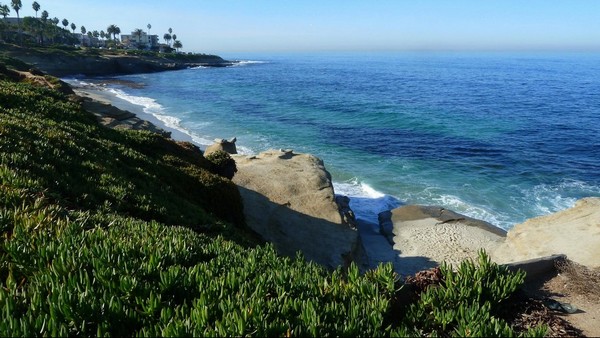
[493,198,600,268]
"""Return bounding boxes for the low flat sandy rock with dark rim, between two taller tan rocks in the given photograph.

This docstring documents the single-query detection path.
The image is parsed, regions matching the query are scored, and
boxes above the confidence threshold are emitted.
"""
[379,205,506,275]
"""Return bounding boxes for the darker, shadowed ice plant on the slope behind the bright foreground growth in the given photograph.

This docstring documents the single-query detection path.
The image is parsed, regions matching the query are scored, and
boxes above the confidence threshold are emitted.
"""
[0,78,243,230]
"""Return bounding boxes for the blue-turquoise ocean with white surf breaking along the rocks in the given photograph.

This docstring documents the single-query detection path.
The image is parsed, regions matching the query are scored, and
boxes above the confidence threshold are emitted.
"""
[64,52,600,230]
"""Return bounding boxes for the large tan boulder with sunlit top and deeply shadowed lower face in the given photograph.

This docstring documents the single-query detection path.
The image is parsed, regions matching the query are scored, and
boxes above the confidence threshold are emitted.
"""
[233,150,359,268]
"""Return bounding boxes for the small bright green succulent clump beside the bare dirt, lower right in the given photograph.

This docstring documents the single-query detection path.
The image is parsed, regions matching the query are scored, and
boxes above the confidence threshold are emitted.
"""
[395,251,545,337]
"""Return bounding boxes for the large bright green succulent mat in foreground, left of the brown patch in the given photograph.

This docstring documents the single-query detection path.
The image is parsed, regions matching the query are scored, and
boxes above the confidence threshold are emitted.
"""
[0,193,404,337]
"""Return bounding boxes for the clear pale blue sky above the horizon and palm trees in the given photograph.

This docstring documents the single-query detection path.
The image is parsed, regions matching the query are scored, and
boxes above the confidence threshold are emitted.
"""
[9,0,600,54]
